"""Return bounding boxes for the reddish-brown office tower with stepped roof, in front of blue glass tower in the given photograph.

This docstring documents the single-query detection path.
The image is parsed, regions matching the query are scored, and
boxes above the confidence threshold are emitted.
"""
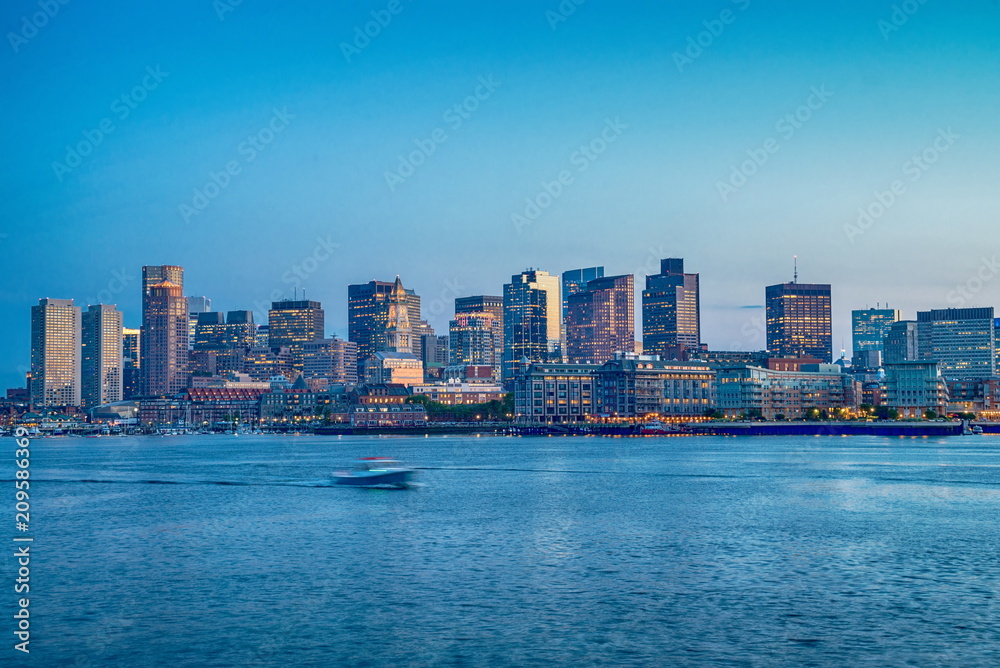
[566,274,635,364]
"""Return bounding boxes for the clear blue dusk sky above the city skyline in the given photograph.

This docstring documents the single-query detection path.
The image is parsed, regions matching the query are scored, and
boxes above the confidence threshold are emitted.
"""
[0,0,1000,387]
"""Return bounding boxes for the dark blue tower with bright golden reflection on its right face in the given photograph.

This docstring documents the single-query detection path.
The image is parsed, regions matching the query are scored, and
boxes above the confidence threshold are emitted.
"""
[503,269,562,382]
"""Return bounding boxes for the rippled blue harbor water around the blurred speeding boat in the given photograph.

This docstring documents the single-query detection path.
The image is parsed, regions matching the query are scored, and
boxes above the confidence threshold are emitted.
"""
[0,436,1000,667]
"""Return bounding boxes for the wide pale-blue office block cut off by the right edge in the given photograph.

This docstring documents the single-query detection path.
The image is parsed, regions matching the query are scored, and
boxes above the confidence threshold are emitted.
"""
[917,306,997,381]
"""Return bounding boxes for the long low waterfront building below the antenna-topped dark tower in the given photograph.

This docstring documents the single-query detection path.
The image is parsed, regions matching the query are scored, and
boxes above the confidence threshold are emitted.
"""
[716,364,861,420]
